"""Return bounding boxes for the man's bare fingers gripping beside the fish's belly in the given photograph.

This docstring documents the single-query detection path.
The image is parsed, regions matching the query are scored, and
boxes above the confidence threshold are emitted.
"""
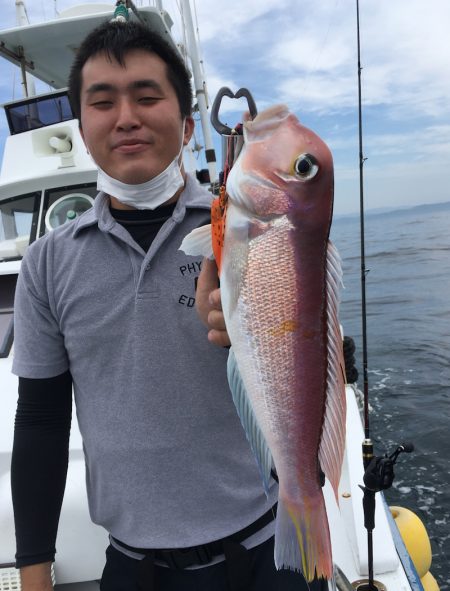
[195,259,231,347]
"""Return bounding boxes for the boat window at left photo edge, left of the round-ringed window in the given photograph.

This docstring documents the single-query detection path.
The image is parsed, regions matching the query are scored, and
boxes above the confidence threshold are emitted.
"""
[0,192,40,261]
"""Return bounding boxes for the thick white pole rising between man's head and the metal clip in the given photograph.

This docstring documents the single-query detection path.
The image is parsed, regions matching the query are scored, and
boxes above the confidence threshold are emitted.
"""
[181,0,218,183]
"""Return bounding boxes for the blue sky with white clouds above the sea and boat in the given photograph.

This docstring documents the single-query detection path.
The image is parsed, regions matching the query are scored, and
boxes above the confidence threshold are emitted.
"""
[0,0,450,214]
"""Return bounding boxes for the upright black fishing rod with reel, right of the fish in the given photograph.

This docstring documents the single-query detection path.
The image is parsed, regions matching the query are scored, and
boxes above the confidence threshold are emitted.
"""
[356,0,414,591]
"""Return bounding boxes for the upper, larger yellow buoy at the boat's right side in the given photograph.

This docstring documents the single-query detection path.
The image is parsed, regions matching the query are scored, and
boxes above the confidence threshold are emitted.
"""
[390,507,431,578]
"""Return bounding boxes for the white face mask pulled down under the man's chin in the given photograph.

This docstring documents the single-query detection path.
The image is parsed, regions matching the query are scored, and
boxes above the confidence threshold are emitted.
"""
[97,122,185,209]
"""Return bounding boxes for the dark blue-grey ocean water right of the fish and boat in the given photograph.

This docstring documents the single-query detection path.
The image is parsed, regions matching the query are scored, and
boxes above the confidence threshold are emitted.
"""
[331,203,450,591]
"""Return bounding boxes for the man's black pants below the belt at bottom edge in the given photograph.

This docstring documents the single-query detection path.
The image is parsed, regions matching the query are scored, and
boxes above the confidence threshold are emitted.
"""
[100,538,328,591]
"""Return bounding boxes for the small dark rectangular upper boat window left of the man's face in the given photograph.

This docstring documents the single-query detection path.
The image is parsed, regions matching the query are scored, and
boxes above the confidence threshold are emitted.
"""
[4,91,75,135]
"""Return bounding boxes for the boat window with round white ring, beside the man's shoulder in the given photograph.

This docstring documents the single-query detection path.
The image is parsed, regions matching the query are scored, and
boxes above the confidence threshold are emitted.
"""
[39,183,97,236]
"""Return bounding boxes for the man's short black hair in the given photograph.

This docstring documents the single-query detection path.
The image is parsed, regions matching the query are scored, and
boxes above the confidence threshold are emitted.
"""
[69,21,192,125]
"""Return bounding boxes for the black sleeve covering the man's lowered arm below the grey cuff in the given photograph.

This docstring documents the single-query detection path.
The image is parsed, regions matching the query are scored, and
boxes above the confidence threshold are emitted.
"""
[11,371,72,568]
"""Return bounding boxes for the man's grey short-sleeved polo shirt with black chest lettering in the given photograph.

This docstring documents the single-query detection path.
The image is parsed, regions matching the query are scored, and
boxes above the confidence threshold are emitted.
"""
[13,177,277,548]
